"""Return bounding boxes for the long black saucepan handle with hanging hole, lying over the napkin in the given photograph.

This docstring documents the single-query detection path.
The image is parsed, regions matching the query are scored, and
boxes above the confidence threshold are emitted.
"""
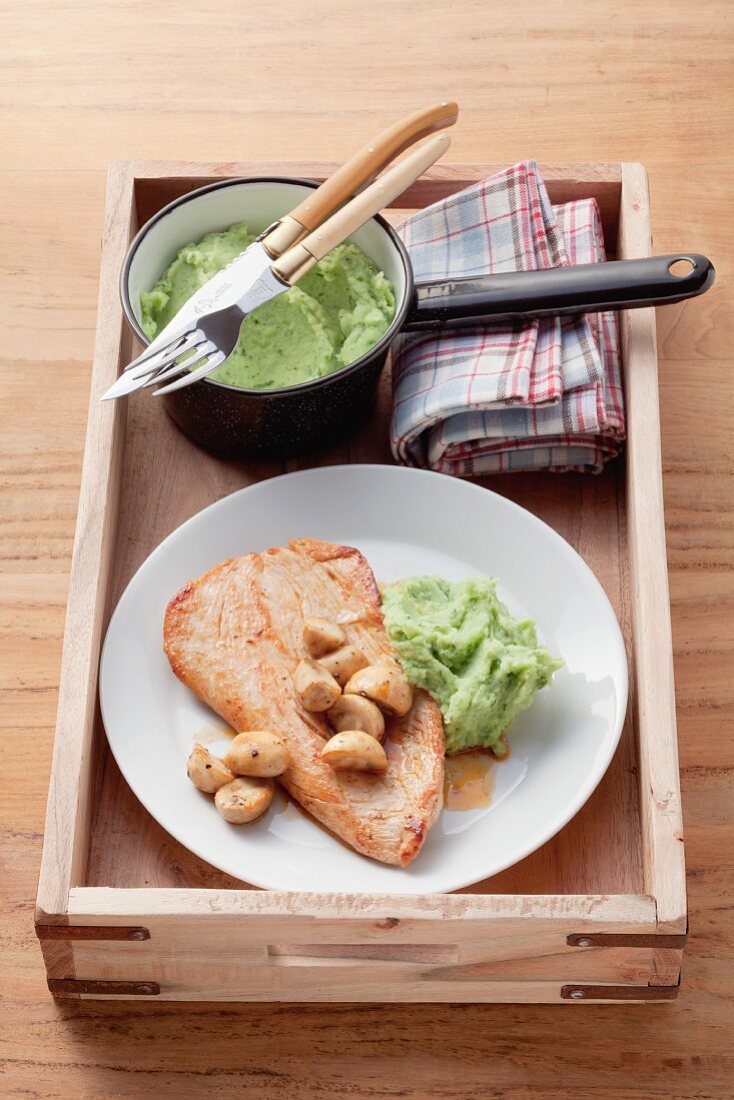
[405,252,715,330]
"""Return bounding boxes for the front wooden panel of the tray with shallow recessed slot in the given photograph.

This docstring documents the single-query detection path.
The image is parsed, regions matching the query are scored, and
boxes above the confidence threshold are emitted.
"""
[65,888,655,1001]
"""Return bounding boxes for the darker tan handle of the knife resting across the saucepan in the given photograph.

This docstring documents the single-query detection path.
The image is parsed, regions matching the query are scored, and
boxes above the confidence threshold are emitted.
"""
[263,102,459,257]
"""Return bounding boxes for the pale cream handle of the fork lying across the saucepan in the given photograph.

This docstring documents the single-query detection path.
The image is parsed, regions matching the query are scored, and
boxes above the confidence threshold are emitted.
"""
[272,134,451,285]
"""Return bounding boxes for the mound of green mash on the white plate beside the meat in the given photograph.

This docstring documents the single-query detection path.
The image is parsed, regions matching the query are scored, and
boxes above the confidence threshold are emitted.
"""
[383,576,563,756]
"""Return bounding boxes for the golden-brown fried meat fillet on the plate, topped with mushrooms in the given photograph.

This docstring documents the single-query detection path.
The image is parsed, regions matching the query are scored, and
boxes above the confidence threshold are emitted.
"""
[164,539,443,866]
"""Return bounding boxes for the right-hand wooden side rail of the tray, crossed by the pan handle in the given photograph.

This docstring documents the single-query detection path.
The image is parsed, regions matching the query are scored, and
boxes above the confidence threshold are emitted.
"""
[618,164,688,933]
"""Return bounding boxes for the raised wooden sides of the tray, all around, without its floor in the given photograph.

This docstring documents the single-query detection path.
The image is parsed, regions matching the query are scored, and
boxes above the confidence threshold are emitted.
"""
[36,162,686,1003]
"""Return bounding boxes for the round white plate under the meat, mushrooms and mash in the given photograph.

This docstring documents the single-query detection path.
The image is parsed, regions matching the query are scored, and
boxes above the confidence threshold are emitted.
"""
[100,465,627,893]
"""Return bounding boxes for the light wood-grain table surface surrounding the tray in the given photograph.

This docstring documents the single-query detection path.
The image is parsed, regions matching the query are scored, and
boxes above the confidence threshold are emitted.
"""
[0,0,734,1100]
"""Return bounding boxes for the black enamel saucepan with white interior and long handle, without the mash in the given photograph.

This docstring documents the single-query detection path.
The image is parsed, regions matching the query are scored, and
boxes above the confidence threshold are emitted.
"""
[120,177,714,458]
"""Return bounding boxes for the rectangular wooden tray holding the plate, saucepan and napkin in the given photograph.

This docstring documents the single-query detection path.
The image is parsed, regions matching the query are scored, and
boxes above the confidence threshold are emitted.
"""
[36,162,686,1002]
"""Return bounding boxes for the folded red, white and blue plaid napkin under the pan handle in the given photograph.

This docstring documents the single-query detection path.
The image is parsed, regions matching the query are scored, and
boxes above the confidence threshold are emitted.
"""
[391,161,624,476]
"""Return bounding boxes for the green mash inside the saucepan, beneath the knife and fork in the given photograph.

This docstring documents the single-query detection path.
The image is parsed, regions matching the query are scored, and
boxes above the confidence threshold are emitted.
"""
[140,223,395,389]
